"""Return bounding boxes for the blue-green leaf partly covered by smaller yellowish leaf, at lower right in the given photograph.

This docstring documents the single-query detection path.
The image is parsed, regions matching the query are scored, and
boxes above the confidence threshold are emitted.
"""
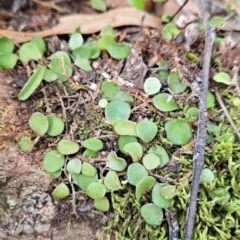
[152,183,173,208]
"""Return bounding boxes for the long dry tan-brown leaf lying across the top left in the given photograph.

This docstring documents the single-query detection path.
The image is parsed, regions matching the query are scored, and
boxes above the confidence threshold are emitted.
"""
[0,8,161,43]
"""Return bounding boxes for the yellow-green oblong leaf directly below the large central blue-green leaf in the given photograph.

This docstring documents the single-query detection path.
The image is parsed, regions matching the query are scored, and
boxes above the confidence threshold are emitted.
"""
[114,120,137,136]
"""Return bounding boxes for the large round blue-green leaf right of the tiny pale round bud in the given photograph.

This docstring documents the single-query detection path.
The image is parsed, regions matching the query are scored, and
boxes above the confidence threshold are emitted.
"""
[105,99,131,125]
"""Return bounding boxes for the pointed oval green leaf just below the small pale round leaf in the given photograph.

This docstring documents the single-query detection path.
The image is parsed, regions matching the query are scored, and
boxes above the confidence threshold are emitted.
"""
[152,93,178,112]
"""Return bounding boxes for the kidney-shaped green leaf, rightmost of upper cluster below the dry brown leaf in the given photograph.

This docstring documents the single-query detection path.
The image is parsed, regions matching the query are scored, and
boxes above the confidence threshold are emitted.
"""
[106,42,131,60]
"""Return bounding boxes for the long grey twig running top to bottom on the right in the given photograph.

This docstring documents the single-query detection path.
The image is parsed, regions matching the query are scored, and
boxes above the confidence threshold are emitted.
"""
[184,0,215,240]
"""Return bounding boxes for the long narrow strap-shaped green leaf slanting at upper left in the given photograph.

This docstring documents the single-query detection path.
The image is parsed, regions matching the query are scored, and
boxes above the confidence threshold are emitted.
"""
[18,65,46,101]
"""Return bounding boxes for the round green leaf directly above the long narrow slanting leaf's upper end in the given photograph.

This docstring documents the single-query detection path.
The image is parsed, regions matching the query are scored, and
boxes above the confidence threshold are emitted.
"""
[19,42,42,62]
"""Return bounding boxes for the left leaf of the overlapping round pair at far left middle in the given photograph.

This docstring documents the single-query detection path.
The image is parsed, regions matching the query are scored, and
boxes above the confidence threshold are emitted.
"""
[28,112,49,136]
